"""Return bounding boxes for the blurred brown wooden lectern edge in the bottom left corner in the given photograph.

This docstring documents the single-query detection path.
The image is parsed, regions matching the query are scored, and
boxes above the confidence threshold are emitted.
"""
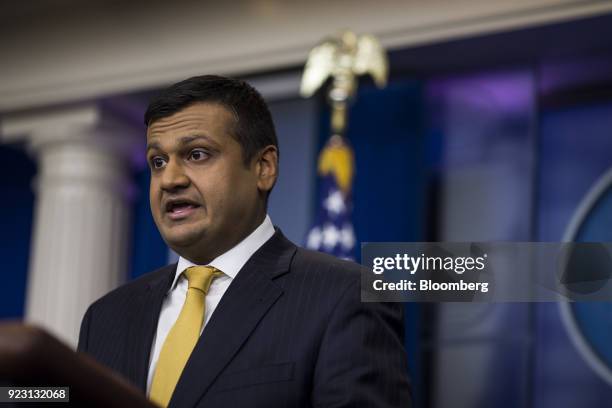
[0,323,154,408]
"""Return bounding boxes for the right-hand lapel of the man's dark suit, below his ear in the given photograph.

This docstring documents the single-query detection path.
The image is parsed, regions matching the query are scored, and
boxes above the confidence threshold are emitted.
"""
[169,230,296,407]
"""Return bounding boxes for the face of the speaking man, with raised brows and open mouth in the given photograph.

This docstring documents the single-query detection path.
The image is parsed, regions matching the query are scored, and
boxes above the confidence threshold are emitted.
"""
[147,103,276,263]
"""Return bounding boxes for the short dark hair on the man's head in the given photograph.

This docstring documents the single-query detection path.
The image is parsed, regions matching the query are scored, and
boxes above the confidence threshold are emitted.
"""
[144,75,278,165]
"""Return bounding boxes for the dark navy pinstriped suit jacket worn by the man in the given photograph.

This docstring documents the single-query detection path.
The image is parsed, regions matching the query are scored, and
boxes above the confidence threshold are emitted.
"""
[78,230,411,408]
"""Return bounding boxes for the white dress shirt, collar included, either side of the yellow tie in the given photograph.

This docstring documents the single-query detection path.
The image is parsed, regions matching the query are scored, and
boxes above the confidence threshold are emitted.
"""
[147,215,274,395]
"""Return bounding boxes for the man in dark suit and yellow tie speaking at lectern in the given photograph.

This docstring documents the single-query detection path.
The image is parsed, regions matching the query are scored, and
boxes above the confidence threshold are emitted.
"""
[79,76,410,408]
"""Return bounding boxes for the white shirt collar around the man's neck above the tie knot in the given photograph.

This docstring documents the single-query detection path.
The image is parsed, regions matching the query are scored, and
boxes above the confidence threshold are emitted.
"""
[169,215,274,292]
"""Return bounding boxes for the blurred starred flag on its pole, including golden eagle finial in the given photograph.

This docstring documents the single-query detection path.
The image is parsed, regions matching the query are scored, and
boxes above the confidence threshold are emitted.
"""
[300,31,389,259]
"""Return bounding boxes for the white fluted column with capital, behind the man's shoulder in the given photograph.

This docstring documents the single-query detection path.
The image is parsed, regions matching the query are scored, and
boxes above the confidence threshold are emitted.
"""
[3,106,142,345]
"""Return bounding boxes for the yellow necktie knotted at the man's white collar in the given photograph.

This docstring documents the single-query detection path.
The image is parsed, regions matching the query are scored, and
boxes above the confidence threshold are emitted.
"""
[149,266,223,407]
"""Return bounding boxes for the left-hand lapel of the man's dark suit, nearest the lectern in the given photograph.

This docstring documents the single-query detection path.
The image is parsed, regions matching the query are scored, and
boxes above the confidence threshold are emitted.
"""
[127,264,176,392]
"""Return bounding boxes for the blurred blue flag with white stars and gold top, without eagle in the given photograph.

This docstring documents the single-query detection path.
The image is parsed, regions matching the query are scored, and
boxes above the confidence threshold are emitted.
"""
[306,136,356,260]
